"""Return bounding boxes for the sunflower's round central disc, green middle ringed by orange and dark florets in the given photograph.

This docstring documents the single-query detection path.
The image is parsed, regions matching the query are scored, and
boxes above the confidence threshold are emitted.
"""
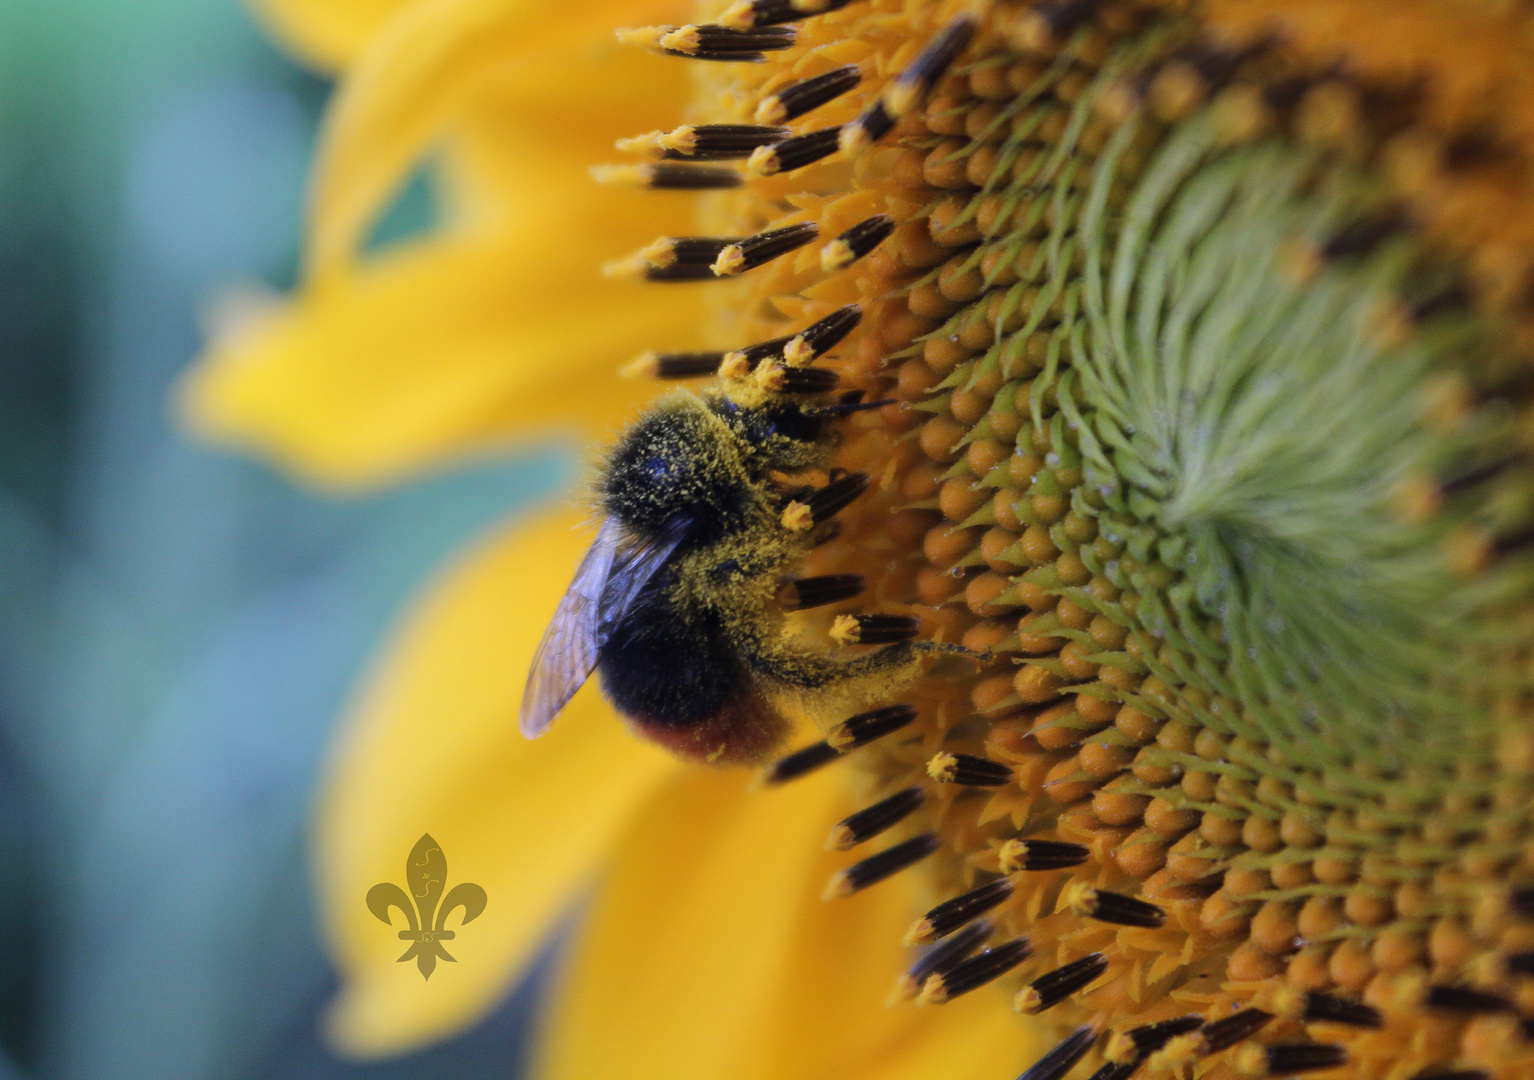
[604,0,1534,1080]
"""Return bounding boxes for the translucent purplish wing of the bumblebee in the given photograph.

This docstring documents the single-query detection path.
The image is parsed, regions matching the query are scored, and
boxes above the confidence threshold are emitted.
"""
[522,519,689,739]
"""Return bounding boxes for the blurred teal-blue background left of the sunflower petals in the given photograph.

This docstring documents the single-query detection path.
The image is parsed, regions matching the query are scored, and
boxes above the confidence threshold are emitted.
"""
[0,0,569,1080]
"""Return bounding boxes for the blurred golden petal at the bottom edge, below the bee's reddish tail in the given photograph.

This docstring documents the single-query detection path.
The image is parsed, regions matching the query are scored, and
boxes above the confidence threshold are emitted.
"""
[538,770,1043,1080]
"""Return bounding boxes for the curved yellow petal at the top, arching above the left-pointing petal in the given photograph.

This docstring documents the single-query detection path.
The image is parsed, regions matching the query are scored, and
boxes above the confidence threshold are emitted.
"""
[310,0,687,278]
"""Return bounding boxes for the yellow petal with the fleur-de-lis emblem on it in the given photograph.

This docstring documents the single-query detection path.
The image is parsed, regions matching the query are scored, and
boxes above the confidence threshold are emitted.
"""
[314,512,683,1055]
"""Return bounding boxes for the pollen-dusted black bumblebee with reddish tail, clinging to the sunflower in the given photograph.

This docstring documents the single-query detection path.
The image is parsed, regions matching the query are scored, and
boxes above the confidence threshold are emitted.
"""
[522,307,956,762]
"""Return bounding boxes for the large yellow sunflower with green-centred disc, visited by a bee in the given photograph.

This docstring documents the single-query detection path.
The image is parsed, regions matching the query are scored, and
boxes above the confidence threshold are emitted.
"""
[184,0,1534,1080]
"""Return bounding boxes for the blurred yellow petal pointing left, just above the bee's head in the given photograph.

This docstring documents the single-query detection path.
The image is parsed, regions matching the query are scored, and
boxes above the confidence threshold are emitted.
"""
[181,227,696,488]
